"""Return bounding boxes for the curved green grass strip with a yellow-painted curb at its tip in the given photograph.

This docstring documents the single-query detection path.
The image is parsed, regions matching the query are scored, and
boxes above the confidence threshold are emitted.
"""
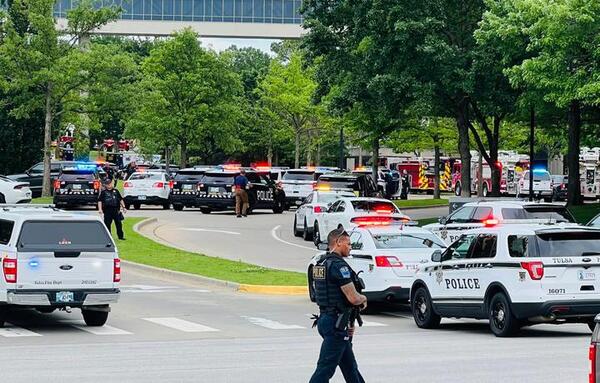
[117,218,306,286]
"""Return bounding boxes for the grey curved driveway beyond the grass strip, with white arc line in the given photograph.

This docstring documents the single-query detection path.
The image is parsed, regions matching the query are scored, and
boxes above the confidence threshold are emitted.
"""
[128,207,448,272]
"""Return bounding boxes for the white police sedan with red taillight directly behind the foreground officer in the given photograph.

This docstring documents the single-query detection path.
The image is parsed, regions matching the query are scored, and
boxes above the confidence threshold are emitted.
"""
[308,224,446,302]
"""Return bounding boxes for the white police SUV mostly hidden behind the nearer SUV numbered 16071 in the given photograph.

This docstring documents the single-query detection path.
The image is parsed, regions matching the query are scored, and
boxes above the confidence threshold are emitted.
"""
[423,200,575,244]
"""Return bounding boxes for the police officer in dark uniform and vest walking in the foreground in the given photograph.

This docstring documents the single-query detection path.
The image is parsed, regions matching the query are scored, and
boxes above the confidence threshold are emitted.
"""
[310,228,367,383]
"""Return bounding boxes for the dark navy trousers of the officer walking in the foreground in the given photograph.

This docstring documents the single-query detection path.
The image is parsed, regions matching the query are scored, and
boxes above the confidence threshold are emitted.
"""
[309,314,365,383]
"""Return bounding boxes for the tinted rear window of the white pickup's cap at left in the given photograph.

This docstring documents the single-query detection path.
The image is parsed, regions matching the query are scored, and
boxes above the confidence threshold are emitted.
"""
[18,221,113,252]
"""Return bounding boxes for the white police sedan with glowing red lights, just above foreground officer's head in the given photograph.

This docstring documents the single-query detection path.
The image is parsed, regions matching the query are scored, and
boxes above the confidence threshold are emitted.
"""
[313,197,410,246]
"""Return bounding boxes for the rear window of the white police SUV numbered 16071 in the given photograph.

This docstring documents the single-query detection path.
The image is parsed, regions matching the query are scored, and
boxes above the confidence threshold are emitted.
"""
[536,230,600,257]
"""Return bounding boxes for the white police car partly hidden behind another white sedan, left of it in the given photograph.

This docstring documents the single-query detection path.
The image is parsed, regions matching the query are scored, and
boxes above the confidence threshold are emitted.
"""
[294,190,354,241]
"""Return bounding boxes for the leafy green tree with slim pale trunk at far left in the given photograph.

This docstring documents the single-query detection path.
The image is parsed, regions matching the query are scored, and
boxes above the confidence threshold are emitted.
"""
[0,0,120,196]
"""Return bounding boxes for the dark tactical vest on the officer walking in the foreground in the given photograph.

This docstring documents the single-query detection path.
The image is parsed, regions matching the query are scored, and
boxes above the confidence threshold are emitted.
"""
[312,254,348,309]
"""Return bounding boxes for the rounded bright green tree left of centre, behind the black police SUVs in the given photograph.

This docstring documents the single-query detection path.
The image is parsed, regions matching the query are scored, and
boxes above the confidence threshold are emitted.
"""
[126,29,242,167]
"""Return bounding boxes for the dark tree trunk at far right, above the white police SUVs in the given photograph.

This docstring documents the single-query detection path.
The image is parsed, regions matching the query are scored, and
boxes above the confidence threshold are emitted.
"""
[567,100,582,206]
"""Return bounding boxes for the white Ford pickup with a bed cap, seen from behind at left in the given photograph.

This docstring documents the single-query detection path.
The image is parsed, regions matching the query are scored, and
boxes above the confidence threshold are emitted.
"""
[0,205,121,326]
